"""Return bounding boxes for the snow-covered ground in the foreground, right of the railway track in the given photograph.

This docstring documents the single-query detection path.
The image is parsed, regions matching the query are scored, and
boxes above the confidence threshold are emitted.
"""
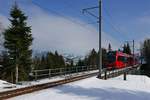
[10,75,150,100]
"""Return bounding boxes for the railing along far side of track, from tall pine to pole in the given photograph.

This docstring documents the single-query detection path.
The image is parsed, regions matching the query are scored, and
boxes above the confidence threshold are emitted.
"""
[30,66,98,80]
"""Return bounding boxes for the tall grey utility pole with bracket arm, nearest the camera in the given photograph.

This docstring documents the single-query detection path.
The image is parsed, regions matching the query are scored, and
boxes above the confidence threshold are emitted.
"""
[83,0,102,78]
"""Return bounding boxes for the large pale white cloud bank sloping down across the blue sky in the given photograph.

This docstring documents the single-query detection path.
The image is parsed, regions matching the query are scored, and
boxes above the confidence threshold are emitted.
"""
[1,4,120,55]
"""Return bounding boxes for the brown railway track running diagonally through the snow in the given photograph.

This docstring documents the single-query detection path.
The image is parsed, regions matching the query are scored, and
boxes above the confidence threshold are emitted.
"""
[0,72,98,100]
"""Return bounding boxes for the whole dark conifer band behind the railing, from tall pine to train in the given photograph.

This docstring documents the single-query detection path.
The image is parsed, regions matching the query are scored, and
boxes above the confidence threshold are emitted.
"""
[32,48,107,70]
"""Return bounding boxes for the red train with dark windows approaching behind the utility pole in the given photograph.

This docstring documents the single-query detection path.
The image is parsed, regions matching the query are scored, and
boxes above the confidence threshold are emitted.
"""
[106,51,138,69]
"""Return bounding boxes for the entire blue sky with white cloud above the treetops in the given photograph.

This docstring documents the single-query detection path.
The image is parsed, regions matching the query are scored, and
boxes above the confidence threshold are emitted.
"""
[0,0,150,55]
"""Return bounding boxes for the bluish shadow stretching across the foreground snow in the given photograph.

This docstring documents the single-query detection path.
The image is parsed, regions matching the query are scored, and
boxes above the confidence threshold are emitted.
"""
[57,84,150,100]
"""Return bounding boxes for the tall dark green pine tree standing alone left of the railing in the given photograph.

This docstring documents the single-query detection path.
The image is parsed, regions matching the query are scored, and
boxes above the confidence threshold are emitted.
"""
[3,3,33,83]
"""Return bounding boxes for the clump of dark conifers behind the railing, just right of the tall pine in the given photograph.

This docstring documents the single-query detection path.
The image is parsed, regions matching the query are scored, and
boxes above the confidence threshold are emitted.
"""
[32,51,65,70]
